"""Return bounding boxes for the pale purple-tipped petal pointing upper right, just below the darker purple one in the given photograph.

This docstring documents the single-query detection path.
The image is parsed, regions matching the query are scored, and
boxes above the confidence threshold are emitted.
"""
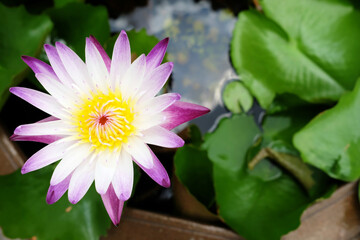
[140,62,174,99]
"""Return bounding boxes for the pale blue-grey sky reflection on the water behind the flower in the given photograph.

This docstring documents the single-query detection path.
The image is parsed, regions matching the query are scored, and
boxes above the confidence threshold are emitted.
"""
[110,0,236,109]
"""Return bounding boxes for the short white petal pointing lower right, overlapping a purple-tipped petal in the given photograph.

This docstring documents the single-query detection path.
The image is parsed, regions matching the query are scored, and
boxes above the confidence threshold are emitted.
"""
[124,136,154,168]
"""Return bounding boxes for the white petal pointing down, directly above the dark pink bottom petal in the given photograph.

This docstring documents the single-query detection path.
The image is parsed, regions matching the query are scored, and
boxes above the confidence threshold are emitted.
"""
[95,153,119,194]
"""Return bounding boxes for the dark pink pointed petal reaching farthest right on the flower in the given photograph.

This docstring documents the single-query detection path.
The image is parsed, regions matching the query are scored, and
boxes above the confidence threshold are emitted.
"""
[161,101,210,130]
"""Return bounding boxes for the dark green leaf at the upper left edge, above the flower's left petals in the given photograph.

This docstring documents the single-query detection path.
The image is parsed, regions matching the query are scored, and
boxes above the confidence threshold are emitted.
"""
[0,3,52,107]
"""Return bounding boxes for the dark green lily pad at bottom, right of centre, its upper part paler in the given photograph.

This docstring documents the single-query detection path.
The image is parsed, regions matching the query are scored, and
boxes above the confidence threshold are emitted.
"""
[203,116,328,240]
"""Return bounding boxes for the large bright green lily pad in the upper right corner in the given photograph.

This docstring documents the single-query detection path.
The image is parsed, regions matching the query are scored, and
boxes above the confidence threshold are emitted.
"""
[231,0,360,108]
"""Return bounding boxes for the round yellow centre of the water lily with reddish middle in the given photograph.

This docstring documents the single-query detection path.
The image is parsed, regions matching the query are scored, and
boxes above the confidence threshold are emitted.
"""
[72,92,135,151]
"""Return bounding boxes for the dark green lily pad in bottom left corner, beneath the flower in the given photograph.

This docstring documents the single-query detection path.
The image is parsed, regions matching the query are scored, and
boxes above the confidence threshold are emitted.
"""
[0,167,110,240]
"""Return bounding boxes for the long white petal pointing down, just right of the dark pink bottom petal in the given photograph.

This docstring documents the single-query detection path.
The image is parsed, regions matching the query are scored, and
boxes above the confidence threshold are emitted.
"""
[112,151,134,201]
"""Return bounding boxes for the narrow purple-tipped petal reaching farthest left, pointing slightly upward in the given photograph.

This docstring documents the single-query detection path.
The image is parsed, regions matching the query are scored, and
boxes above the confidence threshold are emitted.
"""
[10,87,64,118]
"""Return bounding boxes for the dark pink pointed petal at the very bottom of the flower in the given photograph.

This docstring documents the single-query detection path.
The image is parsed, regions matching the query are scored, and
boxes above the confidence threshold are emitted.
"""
[101,185,124,225]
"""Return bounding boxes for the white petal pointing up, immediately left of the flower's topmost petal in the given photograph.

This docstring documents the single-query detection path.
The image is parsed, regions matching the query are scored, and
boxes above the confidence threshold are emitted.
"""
[85,38,110,93]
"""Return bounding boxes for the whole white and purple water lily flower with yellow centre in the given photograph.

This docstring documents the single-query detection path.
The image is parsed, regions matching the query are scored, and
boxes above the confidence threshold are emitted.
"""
[10,31,209,225]
